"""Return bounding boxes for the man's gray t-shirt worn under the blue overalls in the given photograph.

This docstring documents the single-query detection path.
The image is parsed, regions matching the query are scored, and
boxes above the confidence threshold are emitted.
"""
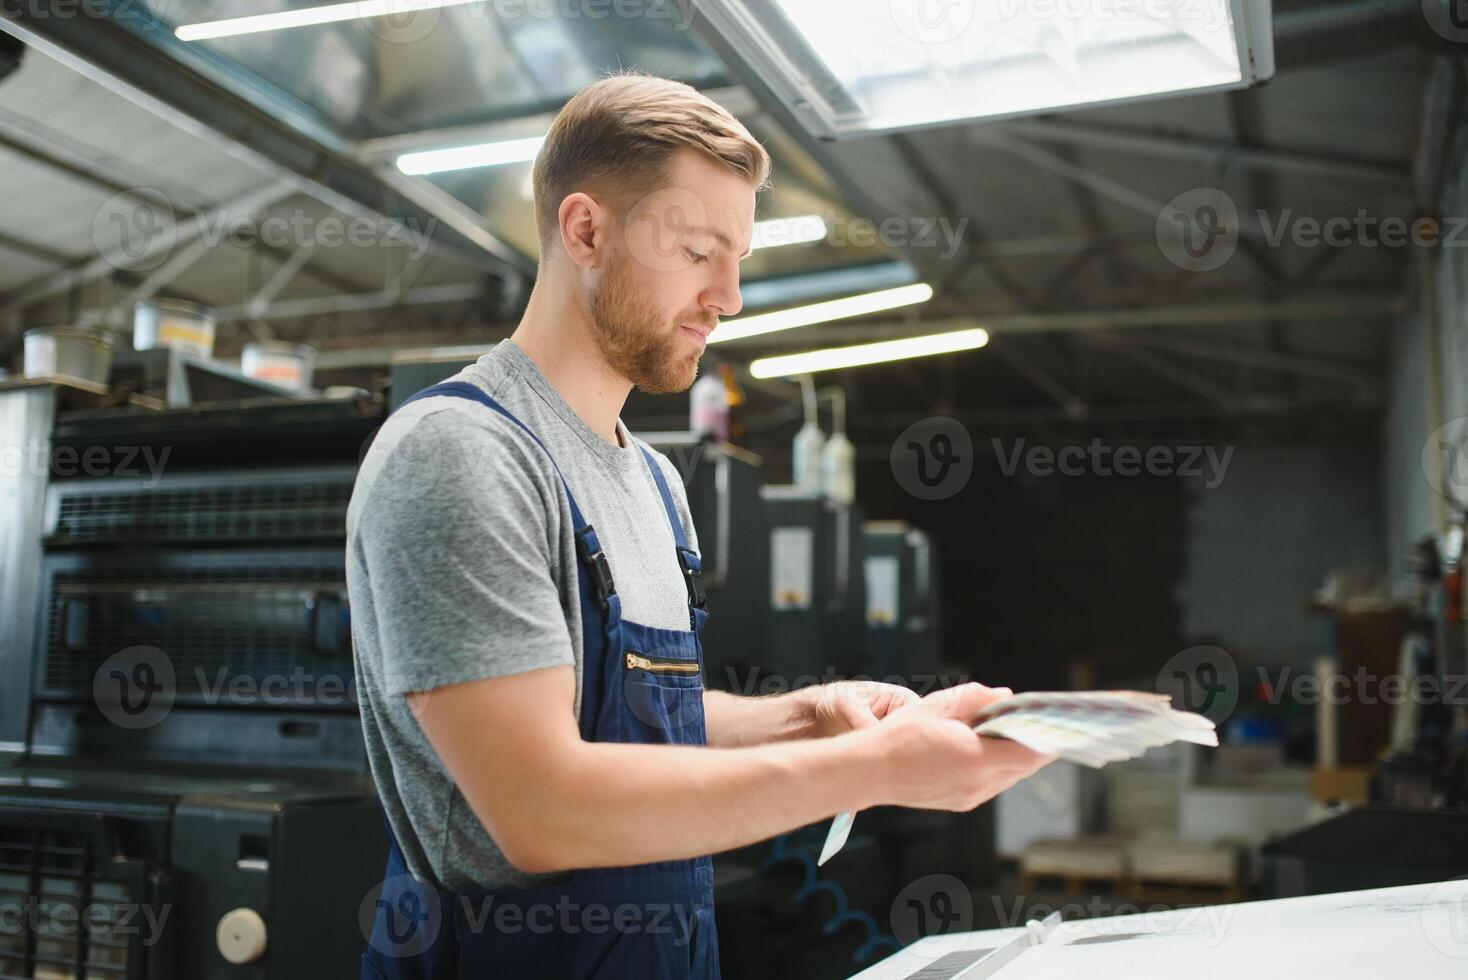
[346,340,697,891]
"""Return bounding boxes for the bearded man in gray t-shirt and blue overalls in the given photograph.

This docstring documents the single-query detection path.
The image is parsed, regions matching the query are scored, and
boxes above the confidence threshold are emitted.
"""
[348,75,1048,980]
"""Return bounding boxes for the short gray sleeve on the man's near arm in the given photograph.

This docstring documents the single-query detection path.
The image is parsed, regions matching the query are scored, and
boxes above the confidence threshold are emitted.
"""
[355,408,575,694]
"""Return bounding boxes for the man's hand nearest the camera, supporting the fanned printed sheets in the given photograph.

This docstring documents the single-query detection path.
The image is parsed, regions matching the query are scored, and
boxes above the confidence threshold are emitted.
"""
[854,684,1054,810]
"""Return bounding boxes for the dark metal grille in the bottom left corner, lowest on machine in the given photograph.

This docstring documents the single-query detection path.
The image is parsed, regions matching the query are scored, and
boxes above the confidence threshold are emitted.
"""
[0,827,137,980]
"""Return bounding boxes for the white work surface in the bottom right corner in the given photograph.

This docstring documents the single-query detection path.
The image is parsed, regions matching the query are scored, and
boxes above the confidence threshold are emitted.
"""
[851,880,1468,980]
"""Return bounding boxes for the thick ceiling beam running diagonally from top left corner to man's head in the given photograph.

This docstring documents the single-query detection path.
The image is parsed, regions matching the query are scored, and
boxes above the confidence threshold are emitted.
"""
[0,11,534,276]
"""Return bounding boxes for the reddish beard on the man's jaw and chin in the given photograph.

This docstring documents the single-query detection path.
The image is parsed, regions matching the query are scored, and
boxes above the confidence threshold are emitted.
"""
[590,258,699,395]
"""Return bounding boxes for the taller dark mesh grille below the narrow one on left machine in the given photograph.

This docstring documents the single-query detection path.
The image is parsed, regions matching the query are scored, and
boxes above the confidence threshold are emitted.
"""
[44,565,352,707]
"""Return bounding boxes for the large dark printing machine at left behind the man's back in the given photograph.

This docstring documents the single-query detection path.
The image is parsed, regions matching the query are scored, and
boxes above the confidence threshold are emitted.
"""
[0,381,386,980]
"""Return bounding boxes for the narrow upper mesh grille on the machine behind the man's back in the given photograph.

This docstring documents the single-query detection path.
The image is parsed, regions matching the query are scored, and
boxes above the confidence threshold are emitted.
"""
[51,477,352,544]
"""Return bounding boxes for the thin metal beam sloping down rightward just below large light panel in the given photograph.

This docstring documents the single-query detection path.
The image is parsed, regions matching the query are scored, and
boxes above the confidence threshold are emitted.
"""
[1000,119,1411,189]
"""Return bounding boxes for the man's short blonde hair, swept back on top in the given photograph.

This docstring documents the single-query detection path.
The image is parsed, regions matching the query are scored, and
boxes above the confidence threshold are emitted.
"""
[531,72,769,257]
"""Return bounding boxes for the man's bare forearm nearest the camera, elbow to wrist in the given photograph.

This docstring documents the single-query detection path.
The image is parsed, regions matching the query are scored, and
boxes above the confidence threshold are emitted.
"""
[501,731,882,871]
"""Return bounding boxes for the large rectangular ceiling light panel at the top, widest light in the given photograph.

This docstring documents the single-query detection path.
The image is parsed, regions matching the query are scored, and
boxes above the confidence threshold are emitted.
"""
[700,0,1274,136]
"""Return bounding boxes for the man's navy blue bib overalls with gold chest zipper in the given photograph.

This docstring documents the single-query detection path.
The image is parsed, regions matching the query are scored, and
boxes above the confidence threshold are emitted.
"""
[361,381,719,980]
